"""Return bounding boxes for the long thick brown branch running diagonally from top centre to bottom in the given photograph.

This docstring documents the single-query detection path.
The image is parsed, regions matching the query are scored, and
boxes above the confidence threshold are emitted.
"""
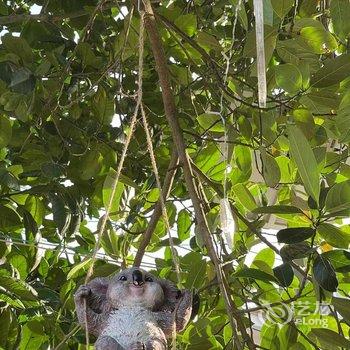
[144,0,256,350]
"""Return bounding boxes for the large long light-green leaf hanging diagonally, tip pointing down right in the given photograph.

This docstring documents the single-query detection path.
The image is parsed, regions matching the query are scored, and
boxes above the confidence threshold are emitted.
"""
[287,125,320,203]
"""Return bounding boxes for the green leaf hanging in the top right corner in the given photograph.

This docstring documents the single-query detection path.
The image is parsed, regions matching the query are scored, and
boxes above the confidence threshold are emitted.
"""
[330,0,350,40]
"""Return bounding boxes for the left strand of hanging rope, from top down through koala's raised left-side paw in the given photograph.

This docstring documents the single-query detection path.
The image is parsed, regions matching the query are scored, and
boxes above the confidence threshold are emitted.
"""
[84,13,144,348]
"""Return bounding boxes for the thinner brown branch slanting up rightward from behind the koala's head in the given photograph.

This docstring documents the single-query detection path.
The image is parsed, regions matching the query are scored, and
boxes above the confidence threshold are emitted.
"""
[134,150,179,266]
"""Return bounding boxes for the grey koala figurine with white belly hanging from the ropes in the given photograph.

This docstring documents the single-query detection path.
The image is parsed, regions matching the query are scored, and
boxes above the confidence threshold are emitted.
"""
[74,267,192,350]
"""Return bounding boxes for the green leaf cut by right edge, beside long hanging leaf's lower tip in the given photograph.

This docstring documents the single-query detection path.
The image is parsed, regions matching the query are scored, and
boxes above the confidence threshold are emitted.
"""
[325,181,350,213]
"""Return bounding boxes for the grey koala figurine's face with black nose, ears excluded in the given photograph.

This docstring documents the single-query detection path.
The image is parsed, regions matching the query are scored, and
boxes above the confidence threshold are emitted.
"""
[107,267,164,310]
